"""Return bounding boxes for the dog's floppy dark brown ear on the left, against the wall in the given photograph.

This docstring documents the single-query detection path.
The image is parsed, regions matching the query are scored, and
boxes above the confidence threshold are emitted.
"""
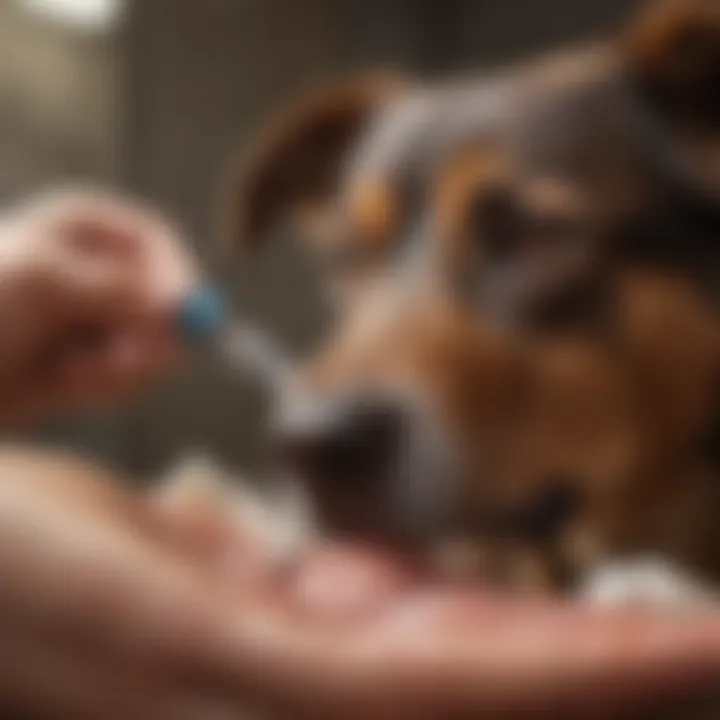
[227,75,406,253]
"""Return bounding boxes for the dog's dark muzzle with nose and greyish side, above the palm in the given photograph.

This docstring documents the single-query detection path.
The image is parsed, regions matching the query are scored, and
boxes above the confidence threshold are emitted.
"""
[274,395,451,543]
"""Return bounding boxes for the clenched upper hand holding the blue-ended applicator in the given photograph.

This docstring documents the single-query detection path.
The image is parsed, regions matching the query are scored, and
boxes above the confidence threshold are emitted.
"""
[0,191,195,427]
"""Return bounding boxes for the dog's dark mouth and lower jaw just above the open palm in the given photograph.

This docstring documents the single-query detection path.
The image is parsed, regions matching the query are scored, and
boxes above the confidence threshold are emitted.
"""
[300,465,583,595]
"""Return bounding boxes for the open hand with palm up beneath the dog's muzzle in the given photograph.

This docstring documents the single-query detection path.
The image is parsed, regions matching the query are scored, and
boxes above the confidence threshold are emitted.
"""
[0,454,720,720]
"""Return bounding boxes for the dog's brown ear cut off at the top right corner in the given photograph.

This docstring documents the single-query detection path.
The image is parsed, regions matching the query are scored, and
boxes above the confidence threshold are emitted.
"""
[626,0,720,126]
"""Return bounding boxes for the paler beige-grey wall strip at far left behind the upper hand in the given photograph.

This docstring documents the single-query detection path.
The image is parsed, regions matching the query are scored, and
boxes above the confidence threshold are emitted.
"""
[0,0,127,462]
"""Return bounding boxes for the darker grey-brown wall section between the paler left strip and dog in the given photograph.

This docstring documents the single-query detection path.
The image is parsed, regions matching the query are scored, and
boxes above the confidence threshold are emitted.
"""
[114,0,648,478]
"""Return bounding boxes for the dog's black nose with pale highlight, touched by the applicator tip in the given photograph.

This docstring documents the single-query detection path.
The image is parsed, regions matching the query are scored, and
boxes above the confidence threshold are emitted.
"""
[275,398,406,488]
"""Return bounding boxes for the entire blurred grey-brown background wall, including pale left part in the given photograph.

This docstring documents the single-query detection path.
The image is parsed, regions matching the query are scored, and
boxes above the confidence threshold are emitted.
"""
[0,0,638,480]
